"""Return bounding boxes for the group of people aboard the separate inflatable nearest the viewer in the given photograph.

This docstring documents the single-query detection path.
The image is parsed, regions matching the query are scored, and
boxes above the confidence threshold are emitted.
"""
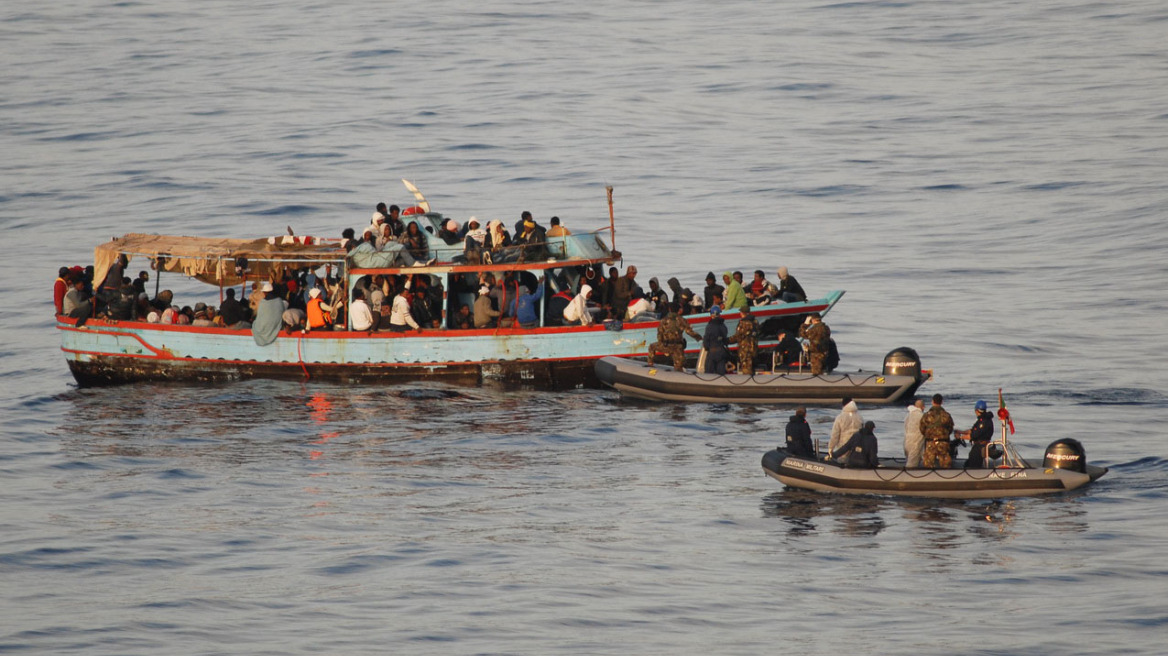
[781,393,1000,469]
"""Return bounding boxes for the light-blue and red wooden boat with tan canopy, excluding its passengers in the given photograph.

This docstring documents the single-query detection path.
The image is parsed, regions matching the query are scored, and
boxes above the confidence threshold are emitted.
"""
[56,184,843,389]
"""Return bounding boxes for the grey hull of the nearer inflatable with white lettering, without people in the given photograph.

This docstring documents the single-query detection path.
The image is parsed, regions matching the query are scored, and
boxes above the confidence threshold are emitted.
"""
[763,449,1107,498]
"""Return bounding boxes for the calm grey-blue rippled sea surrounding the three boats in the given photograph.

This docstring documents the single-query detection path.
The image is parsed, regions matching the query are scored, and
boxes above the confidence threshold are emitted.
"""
[0,0,1168,655]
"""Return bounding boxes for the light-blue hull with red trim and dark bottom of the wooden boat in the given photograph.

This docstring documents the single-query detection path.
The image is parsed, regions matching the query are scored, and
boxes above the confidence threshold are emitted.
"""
[57,292,843,389]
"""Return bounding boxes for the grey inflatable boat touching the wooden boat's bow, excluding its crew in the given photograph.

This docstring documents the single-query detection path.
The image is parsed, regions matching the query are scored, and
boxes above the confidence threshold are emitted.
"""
[596,347,930,405]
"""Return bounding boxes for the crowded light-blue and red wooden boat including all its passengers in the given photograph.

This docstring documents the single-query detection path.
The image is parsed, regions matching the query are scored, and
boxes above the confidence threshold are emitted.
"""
[54,181,843,389]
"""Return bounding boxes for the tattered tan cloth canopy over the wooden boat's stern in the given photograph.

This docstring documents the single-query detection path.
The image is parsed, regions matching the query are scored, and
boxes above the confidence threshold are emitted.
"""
[93,232,345,285]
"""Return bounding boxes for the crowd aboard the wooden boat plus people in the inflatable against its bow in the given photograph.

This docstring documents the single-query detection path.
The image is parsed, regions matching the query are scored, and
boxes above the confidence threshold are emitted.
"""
[54,203,839,374]
